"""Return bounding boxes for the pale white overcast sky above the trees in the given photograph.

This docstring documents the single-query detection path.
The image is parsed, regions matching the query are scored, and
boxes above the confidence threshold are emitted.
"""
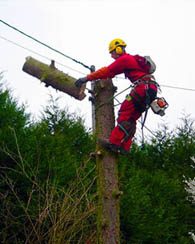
[0,0,195,141]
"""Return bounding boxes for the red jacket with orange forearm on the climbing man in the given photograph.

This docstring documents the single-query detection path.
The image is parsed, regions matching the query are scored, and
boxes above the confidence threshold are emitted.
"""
[87,53,148,82]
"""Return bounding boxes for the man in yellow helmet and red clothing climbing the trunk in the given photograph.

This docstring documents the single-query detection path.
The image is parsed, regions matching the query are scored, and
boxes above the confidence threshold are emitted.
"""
[75,39,158,154]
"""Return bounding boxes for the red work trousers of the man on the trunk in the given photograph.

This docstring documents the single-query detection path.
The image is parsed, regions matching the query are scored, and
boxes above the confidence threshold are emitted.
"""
[109,84,157,151]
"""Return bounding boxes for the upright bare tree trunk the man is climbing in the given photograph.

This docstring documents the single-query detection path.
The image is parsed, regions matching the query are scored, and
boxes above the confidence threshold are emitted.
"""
[95,80,120,244]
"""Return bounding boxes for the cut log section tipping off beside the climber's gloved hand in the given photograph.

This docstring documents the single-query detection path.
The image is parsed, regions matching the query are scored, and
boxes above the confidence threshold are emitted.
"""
[23,57,86,100]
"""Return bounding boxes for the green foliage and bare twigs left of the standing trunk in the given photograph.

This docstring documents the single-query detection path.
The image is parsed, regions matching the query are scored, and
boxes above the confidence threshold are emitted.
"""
[0,81,95,244]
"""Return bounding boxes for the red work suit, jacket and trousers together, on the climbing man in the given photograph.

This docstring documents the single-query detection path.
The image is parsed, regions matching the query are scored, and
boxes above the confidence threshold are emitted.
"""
[87,53,157,151]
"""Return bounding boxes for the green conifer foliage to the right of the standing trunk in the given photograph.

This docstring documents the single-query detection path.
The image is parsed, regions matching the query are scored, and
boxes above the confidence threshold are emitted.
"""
[120,119,195,244]
